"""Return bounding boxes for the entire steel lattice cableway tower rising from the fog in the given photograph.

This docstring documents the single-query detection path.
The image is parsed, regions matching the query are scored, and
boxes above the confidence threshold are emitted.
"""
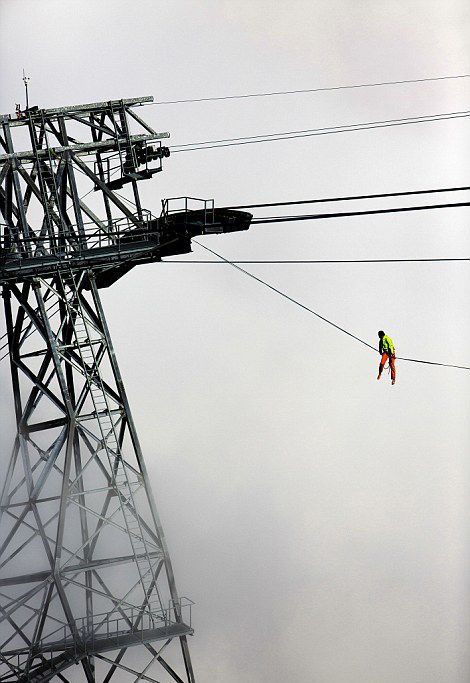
[0,97,251,683]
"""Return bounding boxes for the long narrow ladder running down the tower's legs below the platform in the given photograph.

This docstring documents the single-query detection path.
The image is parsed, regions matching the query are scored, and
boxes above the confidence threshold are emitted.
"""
[61,272,163,612]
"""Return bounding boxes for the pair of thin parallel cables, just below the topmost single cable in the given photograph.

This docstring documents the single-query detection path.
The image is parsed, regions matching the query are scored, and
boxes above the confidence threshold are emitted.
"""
[170,111,470,154]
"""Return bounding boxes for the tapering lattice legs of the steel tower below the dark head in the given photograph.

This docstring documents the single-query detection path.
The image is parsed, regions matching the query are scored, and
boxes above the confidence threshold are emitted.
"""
[0,273,191,681]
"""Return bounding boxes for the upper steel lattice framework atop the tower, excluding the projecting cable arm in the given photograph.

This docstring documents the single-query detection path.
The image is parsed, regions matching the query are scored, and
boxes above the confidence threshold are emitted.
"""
[0,98,169,277]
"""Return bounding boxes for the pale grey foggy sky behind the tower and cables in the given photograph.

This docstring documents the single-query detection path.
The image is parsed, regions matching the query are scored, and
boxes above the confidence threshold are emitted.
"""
[0,0,470,683]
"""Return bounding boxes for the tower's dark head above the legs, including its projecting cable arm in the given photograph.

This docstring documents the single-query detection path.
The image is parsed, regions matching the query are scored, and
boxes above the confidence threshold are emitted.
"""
[0,96,251,286]
